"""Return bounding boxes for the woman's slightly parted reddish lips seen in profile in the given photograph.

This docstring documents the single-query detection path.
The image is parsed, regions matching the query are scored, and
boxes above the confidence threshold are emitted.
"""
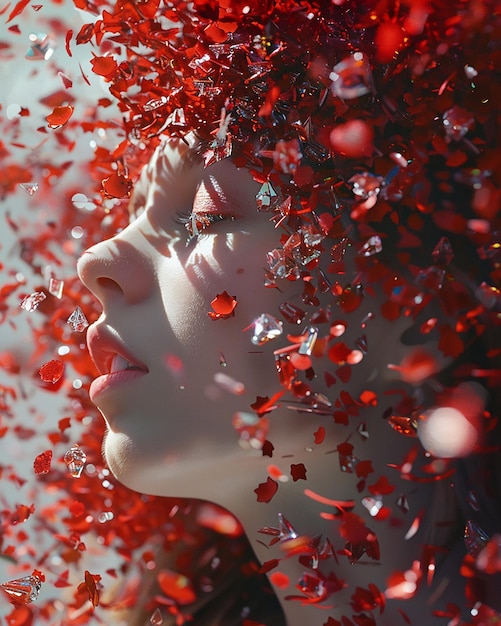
[87,324,148,403]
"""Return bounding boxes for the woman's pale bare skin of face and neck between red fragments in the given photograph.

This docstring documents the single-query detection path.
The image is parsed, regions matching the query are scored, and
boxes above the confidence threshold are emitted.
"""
[78,139,460,626]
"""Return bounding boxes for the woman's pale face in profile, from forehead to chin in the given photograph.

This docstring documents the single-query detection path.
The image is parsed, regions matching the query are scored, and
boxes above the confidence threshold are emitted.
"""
[78,141,308,497]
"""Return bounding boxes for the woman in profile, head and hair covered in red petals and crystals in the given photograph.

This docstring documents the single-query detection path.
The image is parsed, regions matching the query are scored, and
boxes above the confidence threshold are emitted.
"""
[72,2,500,626]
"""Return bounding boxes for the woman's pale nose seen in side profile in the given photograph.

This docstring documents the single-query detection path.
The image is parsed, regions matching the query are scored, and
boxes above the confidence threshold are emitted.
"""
[77,227,155,307]
